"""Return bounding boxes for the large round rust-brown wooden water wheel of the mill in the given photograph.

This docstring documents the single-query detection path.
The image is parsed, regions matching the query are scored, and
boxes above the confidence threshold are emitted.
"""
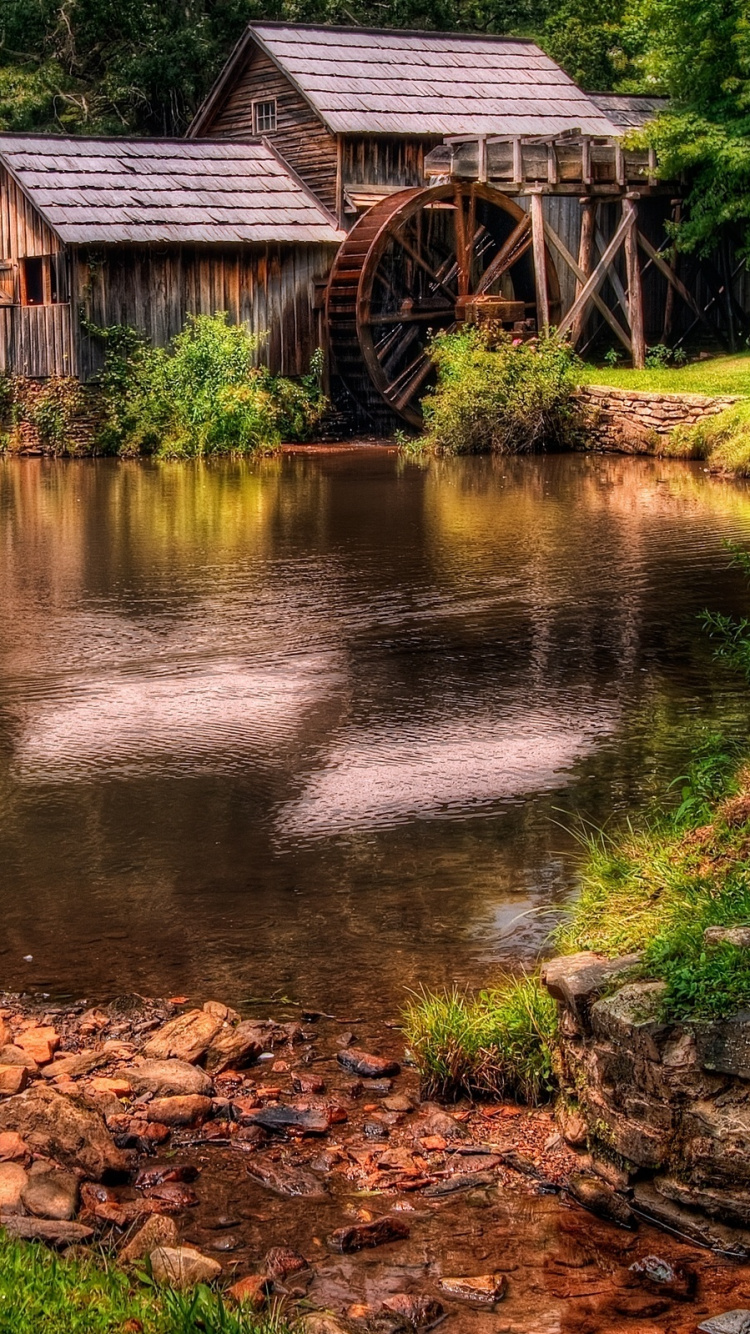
[326,183,560,426]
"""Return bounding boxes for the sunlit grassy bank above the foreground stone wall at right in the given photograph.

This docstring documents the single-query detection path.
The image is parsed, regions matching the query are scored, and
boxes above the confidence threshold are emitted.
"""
[555,740,750,1019]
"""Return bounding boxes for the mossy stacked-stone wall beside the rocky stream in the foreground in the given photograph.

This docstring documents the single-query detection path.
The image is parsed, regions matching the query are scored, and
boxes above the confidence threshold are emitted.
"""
[542,954,750,1258]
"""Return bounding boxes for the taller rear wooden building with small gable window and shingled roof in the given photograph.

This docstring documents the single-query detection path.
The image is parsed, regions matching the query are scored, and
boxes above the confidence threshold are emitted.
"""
[188,23,617,227]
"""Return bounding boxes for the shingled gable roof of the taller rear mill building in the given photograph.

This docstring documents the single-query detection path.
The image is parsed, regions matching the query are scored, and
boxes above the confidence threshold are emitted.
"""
[188,23,617,136]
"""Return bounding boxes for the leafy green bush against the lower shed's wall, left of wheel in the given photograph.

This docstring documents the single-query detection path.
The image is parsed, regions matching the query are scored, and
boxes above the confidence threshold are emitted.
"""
[95,312,326,458]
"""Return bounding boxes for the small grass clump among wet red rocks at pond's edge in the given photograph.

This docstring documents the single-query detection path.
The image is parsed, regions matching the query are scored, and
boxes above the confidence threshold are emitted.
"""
[403,976,556,1103]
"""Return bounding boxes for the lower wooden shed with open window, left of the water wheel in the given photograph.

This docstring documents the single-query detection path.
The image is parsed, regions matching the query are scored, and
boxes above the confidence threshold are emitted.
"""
[0,135,343,380]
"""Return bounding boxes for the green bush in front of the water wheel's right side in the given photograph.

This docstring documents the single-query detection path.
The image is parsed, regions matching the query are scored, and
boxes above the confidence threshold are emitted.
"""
[423,327,579,454]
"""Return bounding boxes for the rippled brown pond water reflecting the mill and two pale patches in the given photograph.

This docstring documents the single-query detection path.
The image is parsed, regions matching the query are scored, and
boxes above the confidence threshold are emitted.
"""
[0,450,750,1014]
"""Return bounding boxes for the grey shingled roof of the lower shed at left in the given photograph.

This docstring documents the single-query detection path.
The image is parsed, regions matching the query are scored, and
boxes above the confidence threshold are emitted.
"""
[0,135,343,244]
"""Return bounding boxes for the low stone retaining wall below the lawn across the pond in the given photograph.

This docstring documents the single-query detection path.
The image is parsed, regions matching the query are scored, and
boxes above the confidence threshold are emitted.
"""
[577,384,738,454]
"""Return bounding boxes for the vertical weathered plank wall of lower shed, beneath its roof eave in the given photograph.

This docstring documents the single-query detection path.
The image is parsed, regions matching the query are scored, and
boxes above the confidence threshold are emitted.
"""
[73,244,336,380]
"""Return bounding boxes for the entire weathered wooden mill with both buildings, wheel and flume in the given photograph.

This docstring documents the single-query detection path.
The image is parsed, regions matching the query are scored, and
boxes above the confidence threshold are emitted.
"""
[0,24,745,424]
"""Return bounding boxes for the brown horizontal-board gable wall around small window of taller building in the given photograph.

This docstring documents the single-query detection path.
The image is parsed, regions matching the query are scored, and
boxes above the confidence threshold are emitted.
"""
[200,49,338,211]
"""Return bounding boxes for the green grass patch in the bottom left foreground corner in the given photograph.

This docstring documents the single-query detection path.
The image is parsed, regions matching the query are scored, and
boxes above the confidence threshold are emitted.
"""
[0,1230,290,1334]
